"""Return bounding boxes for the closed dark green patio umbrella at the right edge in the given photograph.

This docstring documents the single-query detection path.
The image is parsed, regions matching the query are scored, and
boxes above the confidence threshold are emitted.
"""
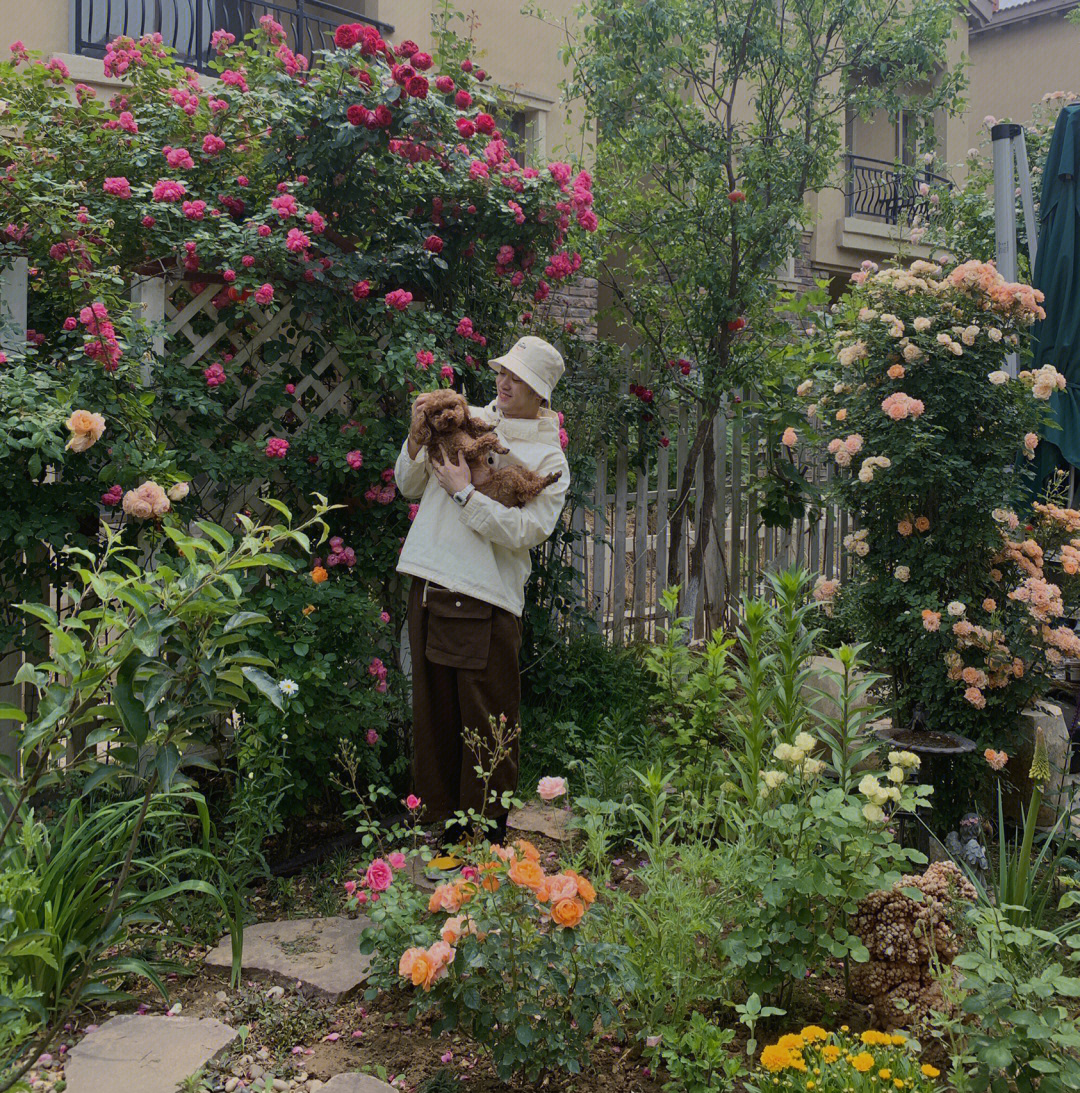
[1032,104,1080,487]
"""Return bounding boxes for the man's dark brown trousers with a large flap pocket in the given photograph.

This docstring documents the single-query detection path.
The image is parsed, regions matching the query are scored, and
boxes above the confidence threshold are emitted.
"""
[409,577,521,820]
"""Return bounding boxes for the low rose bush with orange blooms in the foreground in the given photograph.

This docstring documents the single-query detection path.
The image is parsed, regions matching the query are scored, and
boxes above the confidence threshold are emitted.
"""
[350,839,629,1081]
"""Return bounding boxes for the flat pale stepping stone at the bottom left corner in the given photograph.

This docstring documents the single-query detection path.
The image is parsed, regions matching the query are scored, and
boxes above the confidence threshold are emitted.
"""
[64,1014,236,1093]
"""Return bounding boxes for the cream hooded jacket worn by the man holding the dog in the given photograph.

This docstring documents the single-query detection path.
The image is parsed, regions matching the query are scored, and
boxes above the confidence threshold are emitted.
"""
[394,402,570,616]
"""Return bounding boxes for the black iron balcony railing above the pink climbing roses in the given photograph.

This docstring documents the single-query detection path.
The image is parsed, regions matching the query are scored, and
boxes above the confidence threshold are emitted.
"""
[71,0,394,72]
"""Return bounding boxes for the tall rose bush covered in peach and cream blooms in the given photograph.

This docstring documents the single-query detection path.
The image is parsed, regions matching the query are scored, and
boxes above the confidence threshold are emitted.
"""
[799,261,1080,743]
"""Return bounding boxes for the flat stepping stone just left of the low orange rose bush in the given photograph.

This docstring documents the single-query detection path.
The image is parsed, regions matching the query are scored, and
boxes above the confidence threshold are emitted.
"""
[207,916,372,998]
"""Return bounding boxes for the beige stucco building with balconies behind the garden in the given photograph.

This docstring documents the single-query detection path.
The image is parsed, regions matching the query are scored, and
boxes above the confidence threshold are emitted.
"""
[0,0,1080,295]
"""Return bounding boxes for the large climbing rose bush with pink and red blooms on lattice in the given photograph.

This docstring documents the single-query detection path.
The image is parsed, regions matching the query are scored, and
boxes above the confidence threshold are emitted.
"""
[0,16,596,813]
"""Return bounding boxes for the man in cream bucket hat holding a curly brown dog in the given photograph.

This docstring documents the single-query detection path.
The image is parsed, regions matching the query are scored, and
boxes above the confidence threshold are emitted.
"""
[394,334,570,843]
